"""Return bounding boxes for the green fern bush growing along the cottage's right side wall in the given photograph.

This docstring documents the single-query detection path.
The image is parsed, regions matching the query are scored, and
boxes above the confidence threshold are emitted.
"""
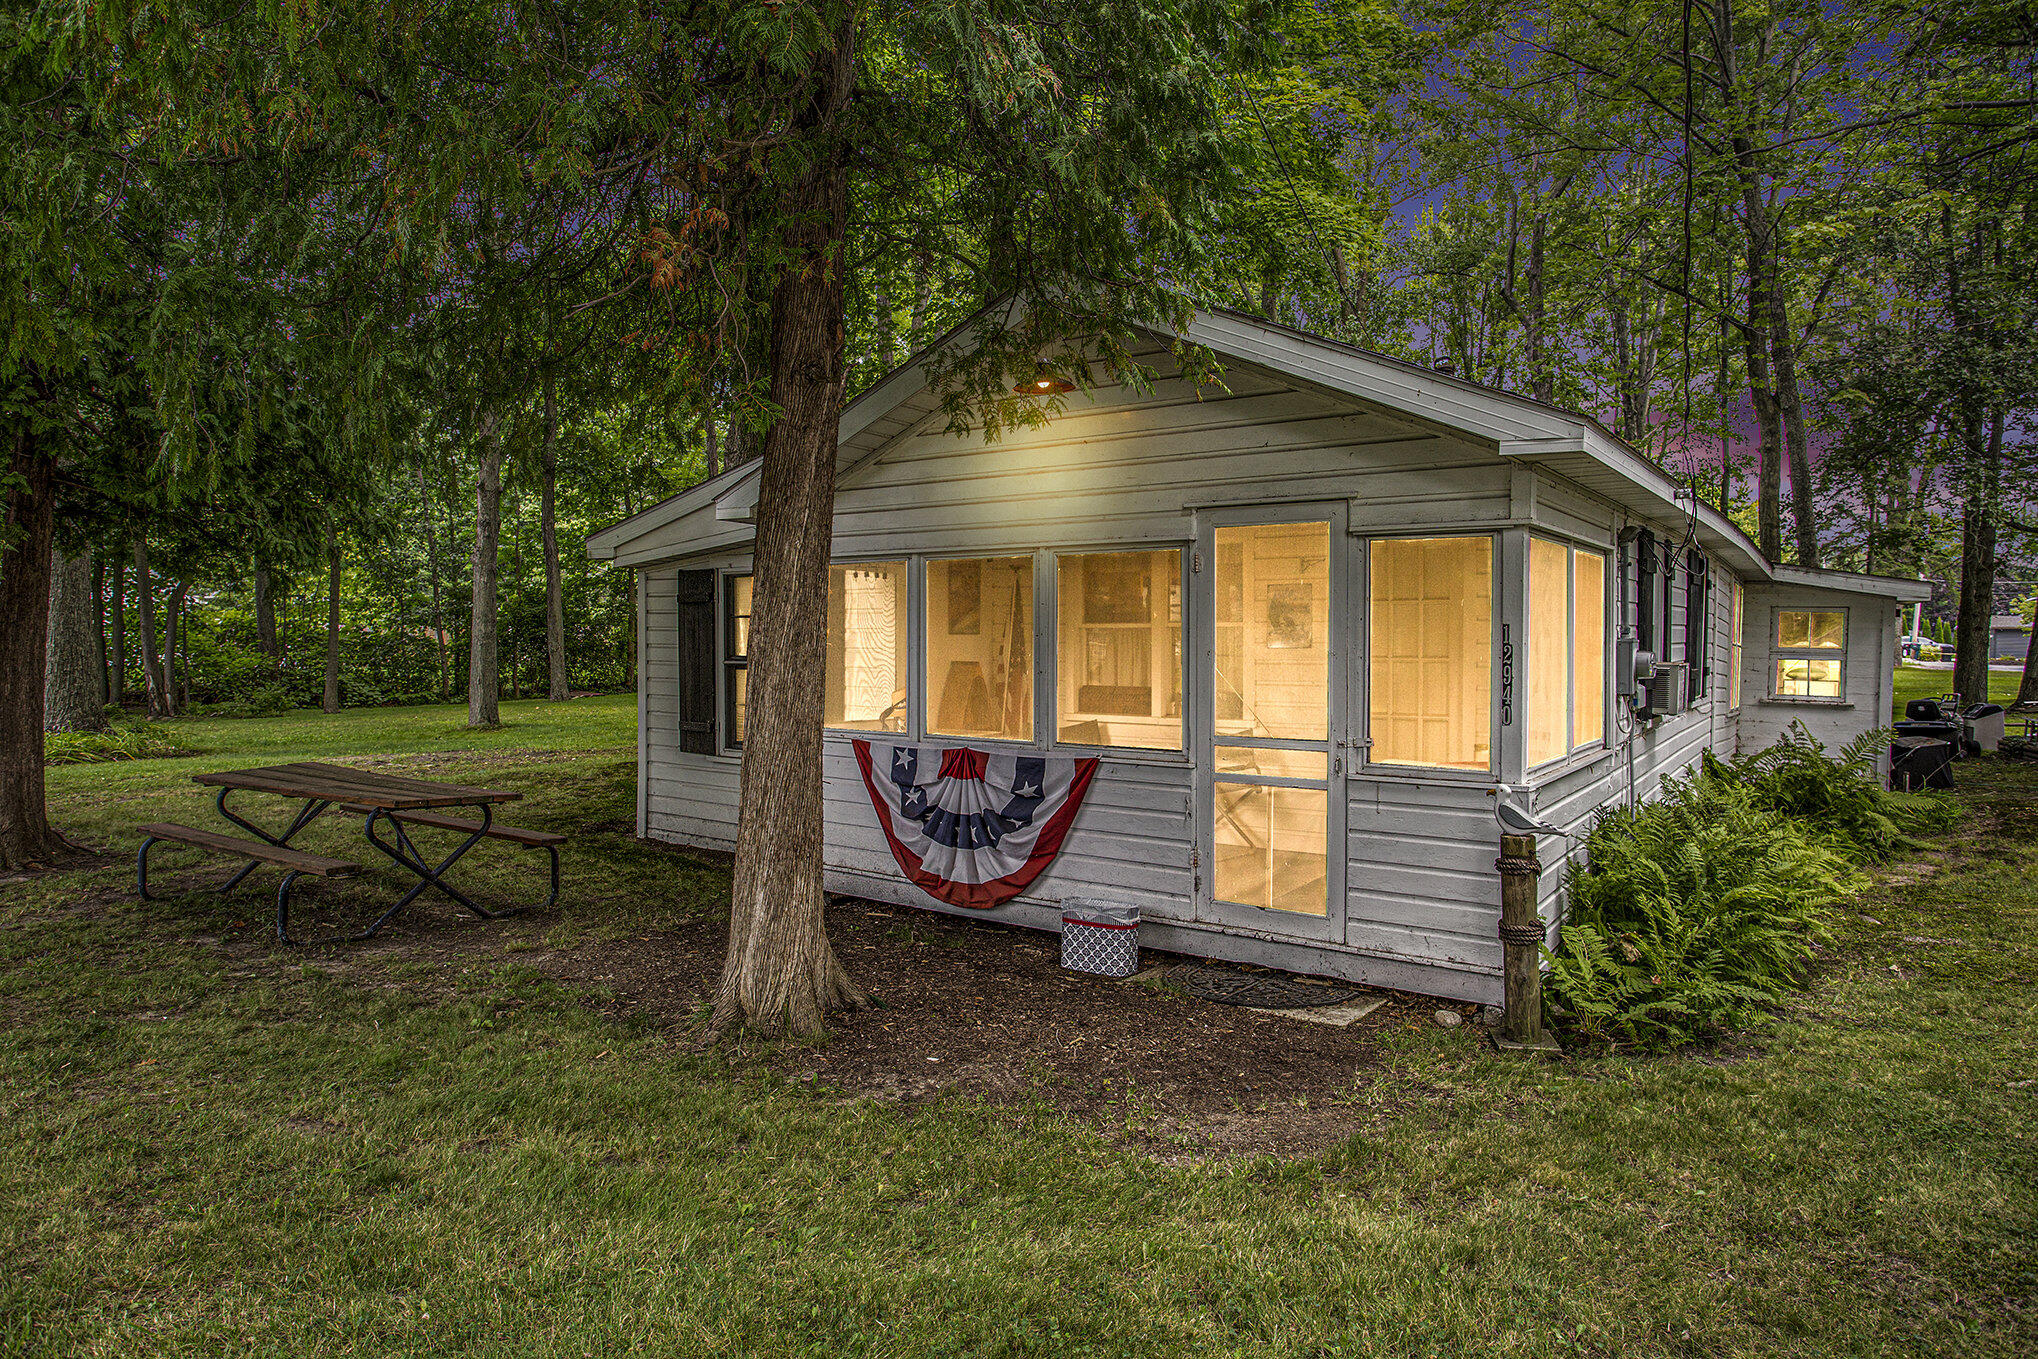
[1545,727,1950,1049]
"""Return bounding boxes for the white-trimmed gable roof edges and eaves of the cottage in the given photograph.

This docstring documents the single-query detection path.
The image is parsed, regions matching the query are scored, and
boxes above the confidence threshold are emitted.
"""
[587,300,1930,601]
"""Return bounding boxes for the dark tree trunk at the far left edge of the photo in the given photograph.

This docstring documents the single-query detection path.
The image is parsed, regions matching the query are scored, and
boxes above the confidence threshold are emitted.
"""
[0,418,71,870]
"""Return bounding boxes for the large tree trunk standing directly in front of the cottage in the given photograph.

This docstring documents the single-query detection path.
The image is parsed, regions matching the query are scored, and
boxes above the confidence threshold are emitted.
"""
[711,18,868,1035]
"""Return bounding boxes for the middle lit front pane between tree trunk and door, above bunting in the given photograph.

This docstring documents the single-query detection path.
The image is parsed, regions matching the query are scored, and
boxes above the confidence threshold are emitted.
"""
[927,556,1033,742]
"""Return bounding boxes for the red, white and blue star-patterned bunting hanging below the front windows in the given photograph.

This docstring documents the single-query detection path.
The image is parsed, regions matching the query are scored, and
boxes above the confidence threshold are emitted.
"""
[852,740,1096,911]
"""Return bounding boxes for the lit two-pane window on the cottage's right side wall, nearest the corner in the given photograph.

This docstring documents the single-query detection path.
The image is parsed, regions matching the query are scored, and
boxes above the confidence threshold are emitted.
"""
[1526,538,1606,764]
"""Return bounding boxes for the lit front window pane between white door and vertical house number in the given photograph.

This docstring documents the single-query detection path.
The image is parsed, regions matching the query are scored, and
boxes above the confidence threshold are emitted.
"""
[1370,538,1494,770]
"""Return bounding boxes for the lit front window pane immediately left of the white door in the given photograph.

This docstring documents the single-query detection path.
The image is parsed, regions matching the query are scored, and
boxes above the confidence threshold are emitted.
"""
[1056,548,1182,750]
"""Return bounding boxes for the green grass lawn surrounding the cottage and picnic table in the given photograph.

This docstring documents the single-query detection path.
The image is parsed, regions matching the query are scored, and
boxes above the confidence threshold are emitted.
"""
[0,689,2038,1359]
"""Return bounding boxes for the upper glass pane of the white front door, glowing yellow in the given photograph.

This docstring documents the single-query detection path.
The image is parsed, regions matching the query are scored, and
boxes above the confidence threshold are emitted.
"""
[1213,524,1331,742]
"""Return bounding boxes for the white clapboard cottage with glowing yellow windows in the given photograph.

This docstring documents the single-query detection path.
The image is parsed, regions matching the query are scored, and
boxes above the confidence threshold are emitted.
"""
[589,312,1924,1002]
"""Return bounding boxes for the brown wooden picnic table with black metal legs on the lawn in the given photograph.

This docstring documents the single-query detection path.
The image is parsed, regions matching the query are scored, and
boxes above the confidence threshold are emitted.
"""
[135,760,567,943]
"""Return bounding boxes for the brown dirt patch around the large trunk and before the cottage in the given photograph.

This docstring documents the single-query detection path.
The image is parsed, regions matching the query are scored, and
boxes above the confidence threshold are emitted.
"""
[165,859,1482,1157]
